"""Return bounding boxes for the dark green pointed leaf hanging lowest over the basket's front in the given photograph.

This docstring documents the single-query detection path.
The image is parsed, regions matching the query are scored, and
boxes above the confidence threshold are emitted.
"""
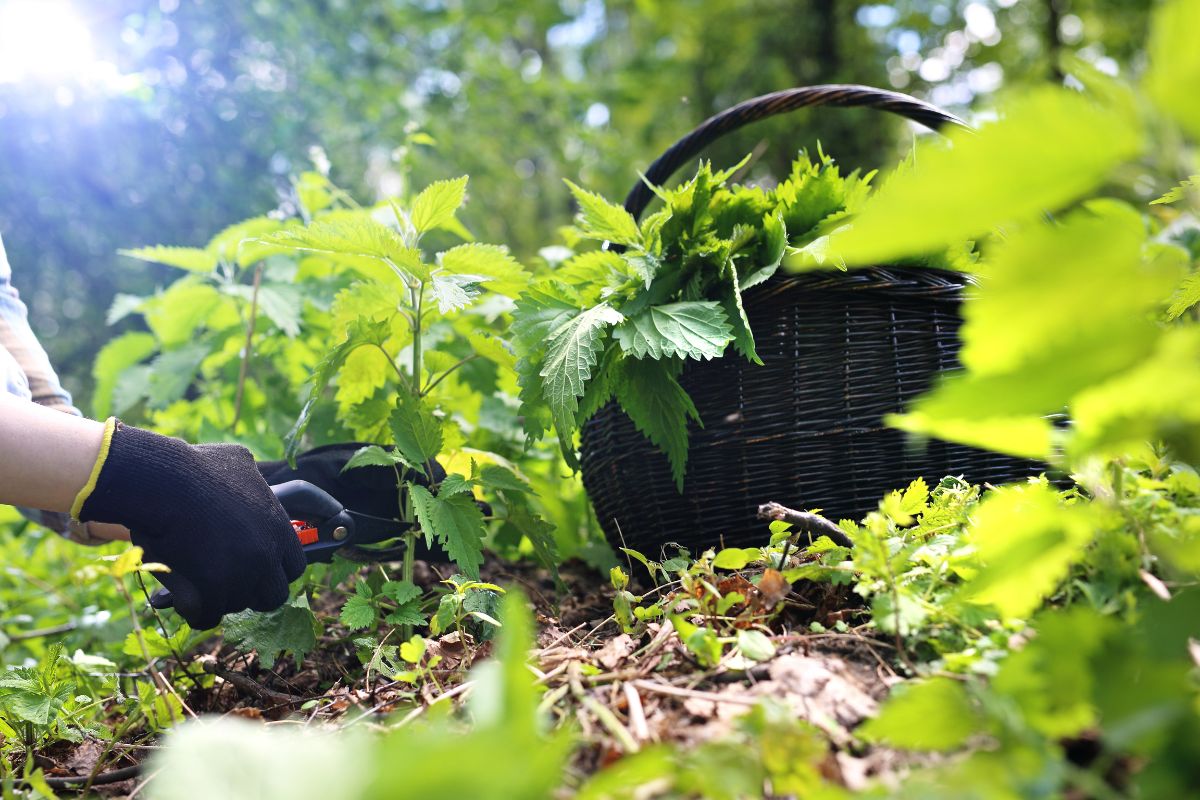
[617,359,700,492]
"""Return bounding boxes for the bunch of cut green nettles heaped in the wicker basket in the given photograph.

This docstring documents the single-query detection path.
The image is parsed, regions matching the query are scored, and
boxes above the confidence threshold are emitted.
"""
[512,149,973,491]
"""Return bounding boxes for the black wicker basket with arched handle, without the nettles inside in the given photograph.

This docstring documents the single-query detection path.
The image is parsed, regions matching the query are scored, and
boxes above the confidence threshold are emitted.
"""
[581,86,1040,553]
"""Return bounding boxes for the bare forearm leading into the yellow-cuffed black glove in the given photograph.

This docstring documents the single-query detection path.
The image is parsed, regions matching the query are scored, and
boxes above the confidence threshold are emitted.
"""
[0,393,104,512]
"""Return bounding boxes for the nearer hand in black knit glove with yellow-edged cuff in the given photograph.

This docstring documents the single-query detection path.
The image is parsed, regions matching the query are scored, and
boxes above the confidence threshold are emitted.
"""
[72,419,305,630]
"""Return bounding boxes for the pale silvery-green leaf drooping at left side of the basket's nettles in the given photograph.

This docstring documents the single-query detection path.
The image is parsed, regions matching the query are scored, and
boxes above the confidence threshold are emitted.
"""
[539,303,625,434]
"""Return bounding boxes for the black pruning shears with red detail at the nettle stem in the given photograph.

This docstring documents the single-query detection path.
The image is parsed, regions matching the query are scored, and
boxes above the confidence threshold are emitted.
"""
[150,481,409,608]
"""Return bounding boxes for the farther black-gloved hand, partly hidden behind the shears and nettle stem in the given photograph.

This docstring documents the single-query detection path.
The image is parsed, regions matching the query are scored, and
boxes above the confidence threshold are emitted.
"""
[258,441,446,527]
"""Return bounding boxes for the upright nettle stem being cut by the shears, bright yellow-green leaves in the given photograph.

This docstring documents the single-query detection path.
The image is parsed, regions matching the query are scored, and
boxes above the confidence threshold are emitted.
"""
[259,178,556,626]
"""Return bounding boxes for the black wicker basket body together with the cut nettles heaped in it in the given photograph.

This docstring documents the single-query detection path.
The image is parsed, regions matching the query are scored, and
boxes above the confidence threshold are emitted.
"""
[512,84,1037,552]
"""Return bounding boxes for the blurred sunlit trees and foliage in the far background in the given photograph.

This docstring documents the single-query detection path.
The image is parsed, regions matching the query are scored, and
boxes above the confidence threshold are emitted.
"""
[0,0,1150,407]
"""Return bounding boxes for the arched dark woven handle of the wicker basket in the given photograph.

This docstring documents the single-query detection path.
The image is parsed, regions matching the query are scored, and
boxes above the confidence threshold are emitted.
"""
[625,84,968,219]
